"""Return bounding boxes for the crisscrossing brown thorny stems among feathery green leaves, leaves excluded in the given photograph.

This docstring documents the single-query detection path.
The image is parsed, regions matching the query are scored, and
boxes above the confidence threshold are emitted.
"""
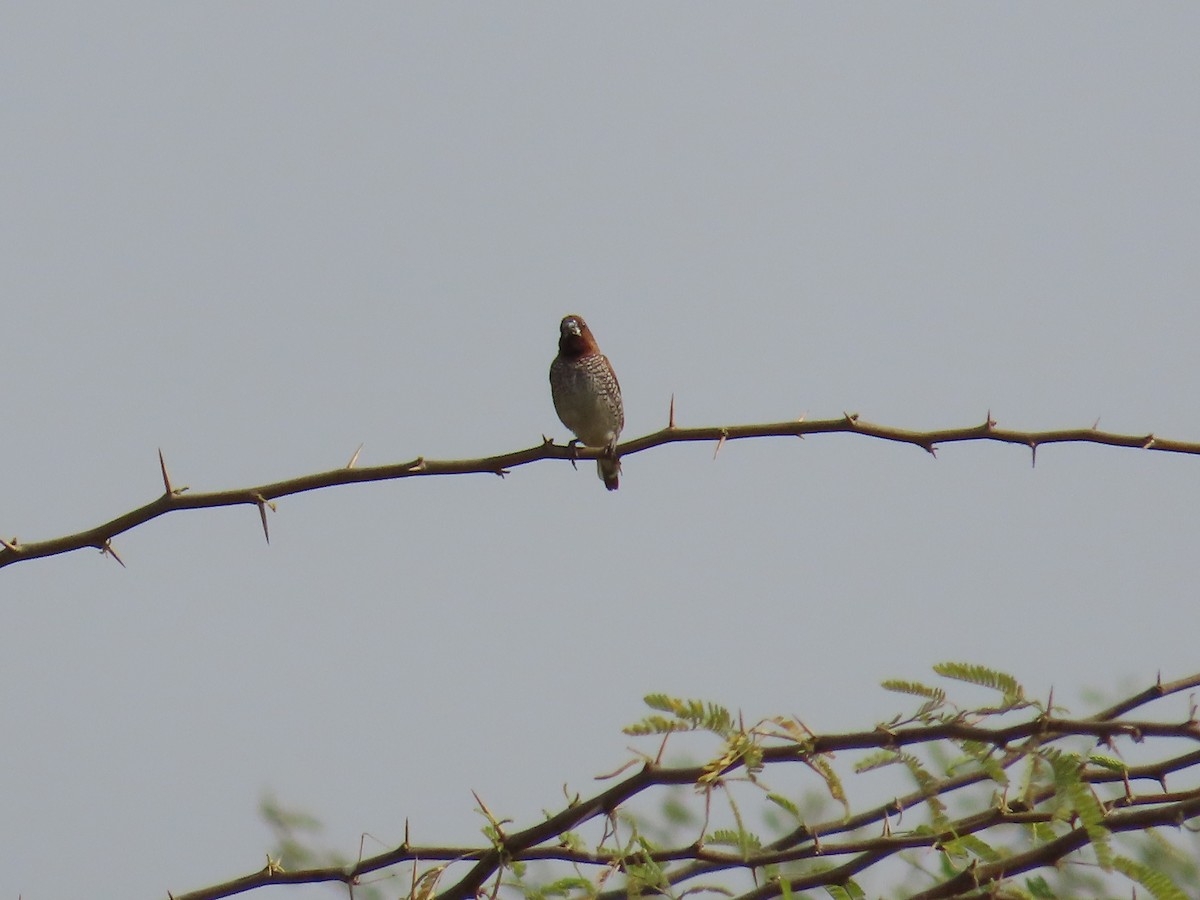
[172,673,1200,900]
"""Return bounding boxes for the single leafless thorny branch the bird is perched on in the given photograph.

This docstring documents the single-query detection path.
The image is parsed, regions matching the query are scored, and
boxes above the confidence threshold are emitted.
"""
[0,410,1200,568]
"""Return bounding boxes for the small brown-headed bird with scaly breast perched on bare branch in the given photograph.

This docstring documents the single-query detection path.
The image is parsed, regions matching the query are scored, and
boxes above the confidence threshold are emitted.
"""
[550,316,625,491]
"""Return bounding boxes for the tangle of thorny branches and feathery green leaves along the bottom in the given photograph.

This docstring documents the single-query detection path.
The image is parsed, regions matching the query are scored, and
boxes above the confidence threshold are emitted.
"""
[176,662,1200,900]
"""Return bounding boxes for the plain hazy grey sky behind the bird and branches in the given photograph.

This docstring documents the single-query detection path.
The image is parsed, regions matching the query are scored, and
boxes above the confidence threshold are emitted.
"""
[0,7,1200,898]
